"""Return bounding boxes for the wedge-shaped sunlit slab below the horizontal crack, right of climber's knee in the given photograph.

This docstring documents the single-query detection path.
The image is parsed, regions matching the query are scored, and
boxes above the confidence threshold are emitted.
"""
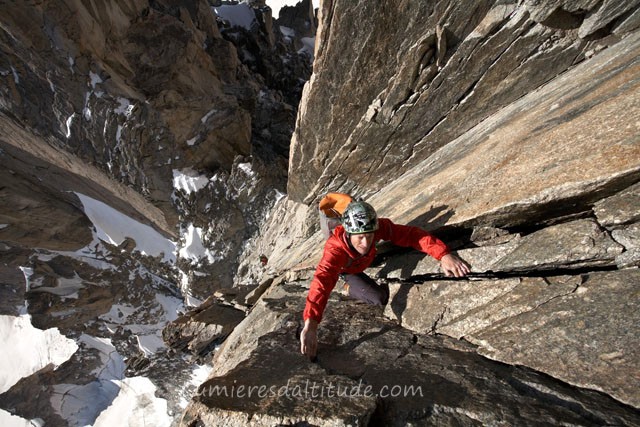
[387,269,640,407]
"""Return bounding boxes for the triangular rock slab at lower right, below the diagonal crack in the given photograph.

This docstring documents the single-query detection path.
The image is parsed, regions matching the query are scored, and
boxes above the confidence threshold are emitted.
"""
[466,269,640,408]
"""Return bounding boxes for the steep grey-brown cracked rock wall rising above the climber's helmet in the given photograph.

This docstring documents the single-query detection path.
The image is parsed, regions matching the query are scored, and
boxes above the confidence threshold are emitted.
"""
[288,0,638,203]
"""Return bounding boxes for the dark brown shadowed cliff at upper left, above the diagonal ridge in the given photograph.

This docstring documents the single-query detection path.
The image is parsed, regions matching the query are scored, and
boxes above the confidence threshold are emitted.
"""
[0,0,313,299]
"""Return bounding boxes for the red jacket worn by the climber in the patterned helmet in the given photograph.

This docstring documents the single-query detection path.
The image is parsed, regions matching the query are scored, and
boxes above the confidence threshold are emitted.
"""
[303,218,450,322]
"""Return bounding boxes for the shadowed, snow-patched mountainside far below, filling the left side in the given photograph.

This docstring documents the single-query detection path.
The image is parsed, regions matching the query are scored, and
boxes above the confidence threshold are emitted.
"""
[0,0,311,426]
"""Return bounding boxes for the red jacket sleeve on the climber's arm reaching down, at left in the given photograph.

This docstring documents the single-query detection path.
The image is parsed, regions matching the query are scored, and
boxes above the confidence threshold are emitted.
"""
[303,236,349,323]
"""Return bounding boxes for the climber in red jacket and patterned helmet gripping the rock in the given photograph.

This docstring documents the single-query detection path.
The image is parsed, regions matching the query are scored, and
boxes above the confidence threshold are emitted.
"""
[300,200,470,359]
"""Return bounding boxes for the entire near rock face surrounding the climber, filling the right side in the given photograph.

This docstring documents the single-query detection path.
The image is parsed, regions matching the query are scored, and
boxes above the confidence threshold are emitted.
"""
[206,1,640,425]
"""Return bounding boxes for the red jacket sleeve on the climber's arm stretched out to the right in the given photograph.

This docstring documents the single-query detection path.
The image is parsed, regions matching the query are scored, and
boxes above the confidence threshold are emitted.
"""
[378,218,451,261]
